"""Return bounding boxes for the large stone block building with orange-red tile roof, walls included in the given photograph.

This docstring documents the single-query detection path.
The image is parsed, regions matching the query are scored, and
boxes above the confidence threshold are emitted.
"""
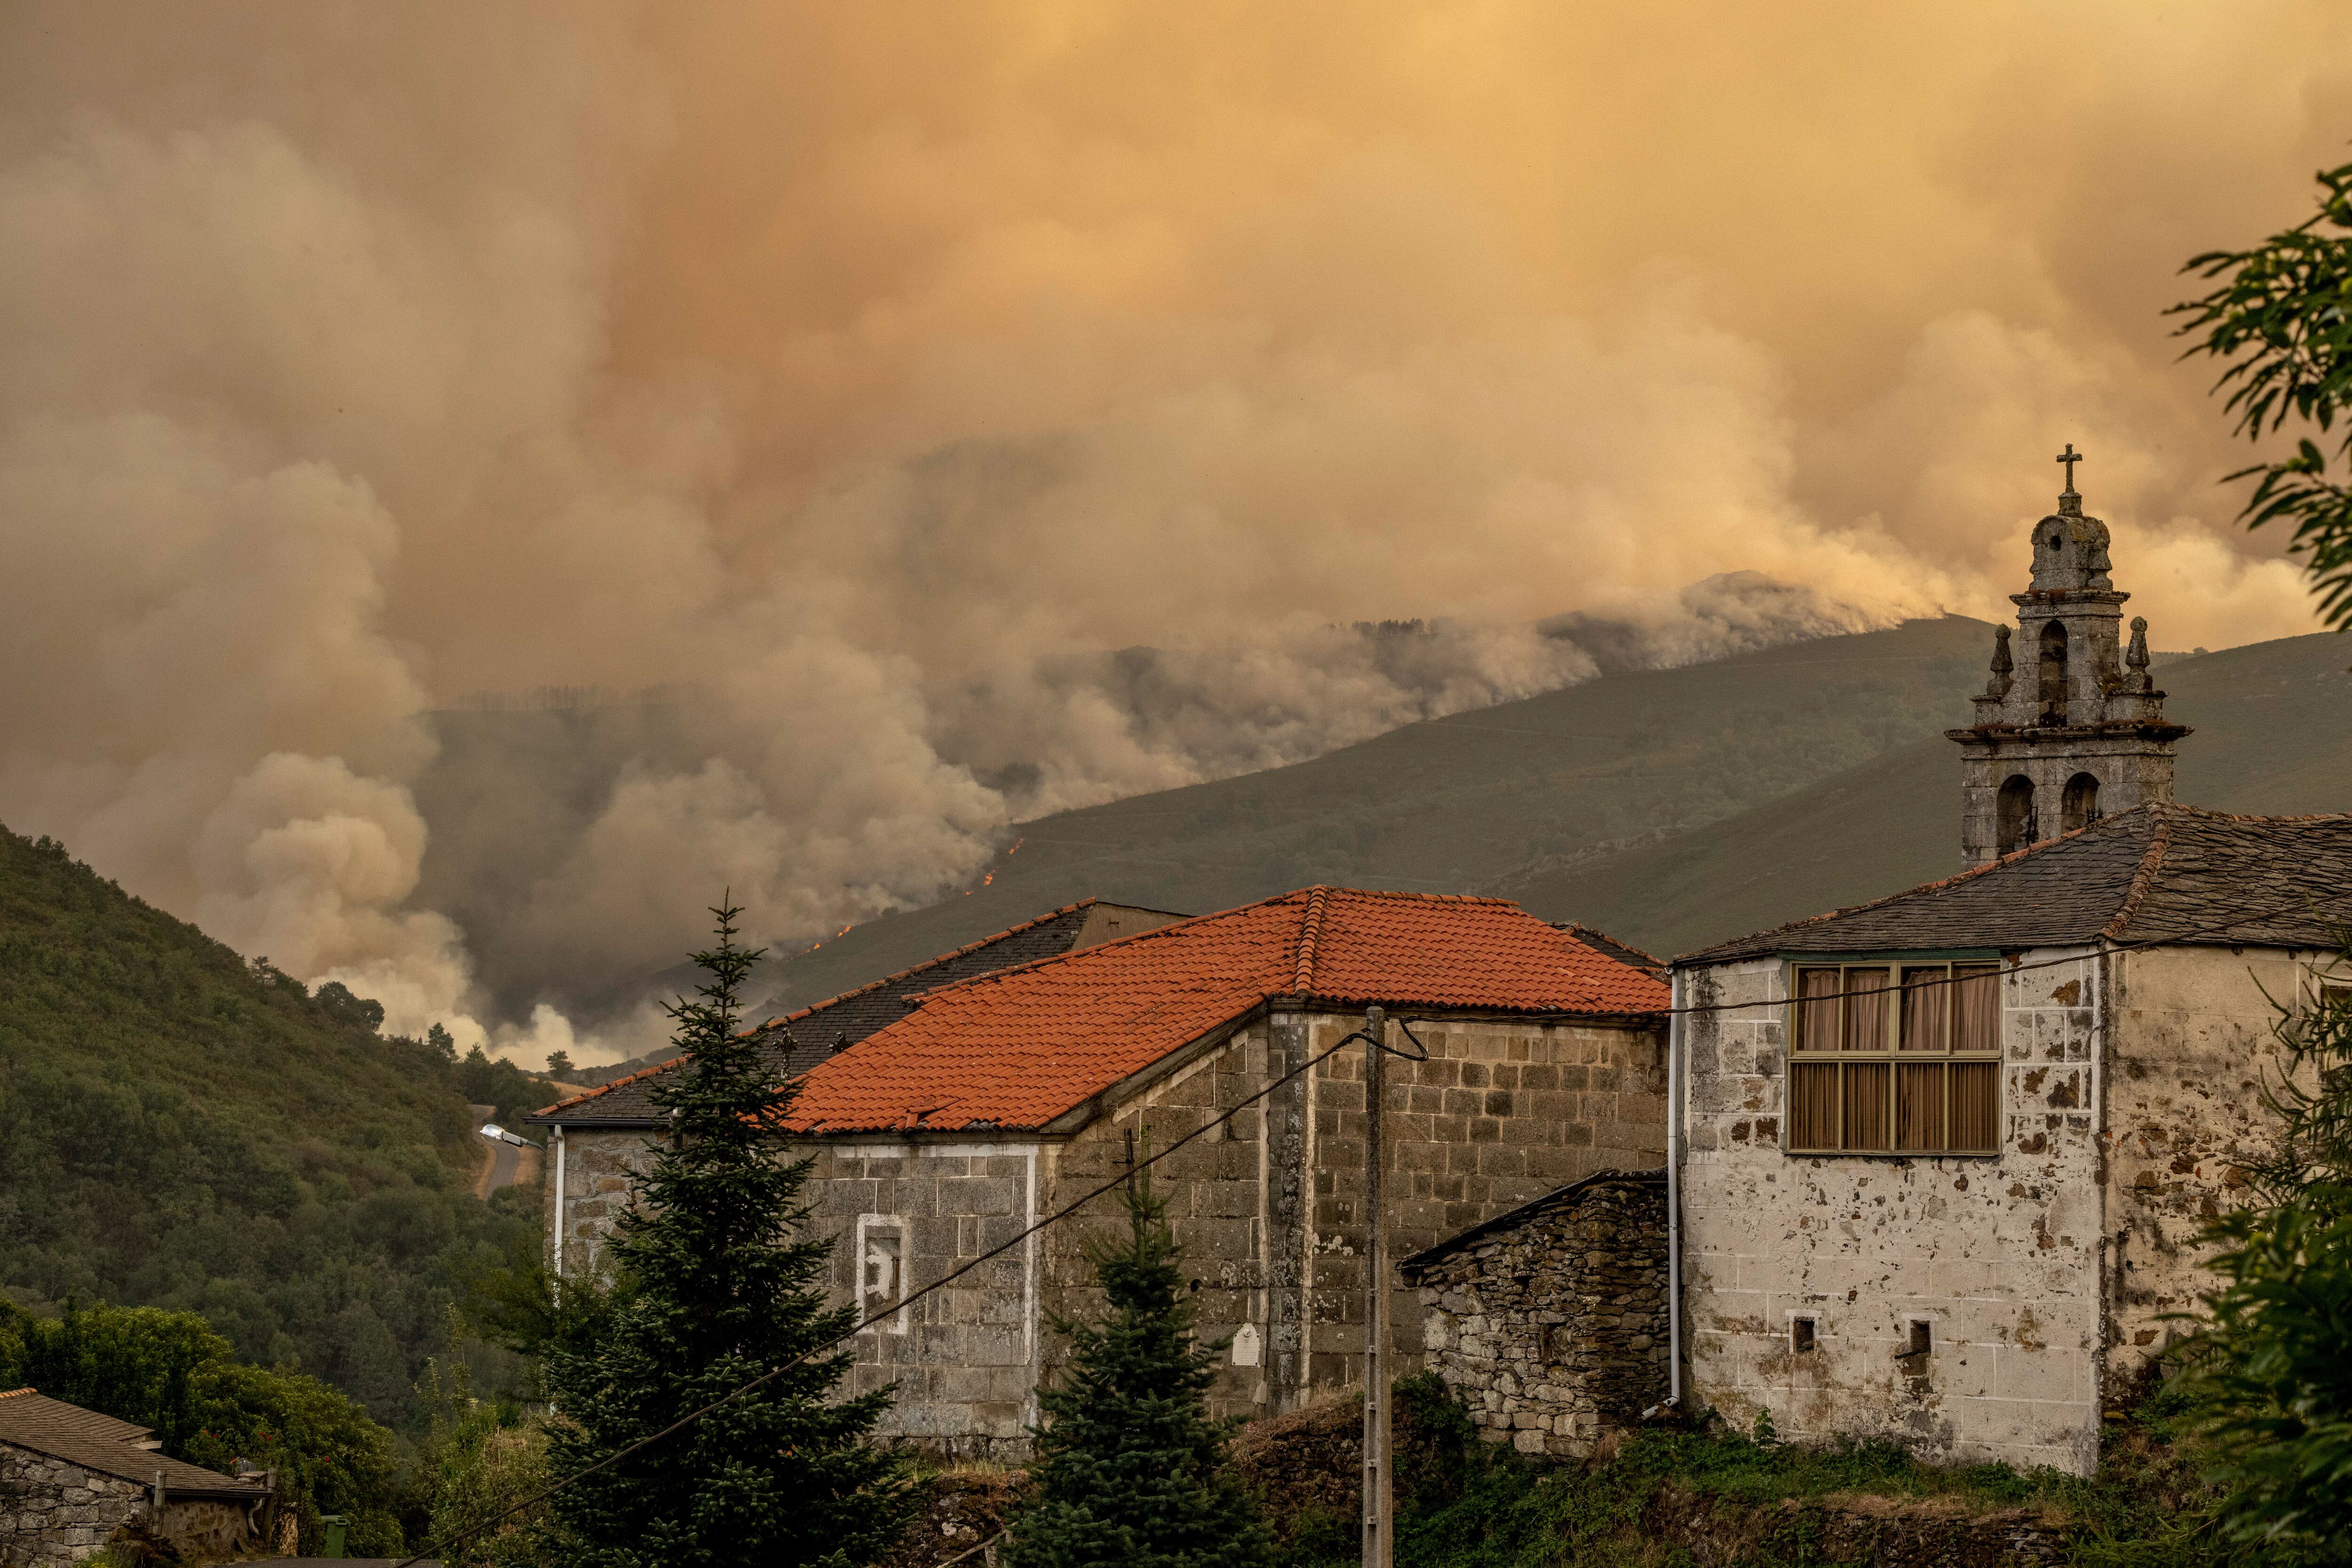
[536,888,1665,1460]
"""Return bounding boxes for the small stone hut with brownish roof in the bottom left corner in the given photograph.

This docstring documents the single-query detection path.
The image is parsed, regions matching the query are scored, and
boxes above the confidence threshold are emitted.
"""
[0,1389,273,1568]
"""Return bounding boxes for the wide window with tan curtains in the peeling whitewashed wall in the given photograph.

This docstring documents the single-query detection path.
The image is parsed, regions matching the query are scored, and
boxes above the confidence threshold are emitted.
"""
[1783,961,2002,1154]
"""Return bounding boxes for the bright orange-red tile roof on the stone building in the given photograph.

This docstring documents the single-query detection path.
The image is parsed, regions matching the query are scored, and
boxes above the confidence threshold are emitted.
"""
[783,888,1668,1133]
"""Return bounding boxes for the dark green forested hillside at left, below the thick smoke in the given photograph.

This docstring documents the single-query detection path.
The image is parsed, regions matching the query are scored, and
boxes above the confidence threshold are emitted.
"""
[0,830,553,1420]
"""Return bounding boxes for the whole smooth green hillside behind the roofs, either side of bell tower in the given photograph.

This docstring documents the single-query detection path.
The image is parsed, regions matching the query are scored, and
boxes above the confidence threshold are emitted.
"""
[748,616,2352,1011]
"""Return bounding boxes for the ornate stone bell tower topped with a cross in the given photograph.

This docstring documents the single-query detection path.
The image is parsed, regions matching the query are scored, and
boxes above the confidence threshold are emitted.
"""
[1945,442,2190,865]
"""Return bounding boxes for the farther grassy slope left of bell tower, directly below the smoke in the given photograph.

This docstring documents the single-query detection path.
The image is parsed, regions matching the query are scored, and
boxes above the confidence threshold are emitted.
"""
[748,616,1992,1006]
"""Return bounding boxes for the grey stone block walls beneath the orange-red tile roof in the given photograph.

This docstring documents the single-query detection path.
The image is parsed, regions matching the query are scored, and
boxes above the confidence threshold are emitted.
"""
[550,1013,1665,1462]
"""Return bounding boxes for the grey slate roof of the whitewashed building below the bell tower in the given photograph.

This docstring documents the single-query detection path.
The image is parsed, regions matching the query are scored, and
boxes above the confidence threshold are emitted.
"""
[1675,806,2352,968]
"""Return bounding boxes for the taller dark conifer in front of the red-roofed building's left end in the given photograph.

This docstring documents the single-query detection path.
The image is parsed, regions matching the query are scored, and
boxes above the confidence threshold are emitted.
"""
[546,905,913,1568]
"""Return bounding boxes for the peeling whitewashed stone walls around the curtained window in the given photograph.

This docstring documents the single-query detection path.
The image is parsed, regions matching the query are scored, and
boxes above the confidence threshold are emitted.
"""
[1684,947,2328,1474]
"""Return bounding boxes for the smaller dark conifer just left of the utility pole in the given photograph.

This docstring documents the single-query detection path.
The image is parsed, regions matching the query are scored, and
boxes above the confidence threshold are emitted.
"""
[1004,1175,1268,1568]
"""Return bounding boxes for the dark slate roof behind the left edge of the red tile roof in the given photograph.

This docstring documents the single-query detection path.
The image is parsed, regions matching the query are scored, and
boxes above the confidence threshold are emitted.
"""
[539,898,1195,1128]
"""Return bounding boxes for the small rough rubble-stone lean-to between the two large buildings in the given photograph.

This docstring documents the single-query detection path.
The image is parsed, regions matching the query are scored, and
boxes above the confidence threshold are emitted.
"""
[1397,1171,1668,1455]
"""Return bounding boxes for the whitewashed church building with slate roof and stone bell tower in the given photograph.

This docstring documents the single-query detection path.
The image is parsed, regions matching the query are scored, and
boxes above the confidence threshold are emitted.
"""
[1670,460,2352,1474]
